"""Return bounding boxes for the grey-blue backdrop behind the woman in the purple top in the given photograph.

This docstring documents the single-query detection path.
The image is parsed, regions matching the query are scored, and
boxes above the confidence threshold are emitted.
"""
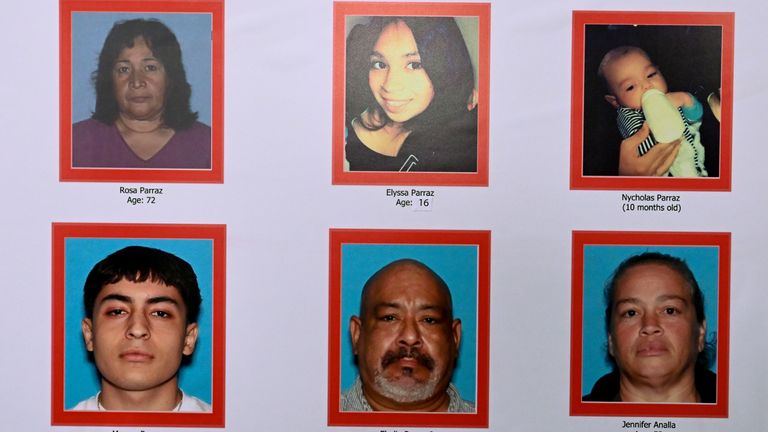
[72,12,212,126]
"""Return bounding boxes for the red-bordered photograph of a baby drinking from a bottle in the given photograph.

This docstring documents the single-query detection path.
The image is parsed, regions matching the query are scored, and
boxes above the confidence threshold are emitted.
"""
[571,11,734,191]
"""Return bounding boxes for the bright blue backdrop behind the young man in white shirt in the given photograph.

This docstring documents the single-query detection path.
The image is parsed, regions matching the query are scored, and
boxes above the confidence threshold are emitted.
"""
[64,238,213,409]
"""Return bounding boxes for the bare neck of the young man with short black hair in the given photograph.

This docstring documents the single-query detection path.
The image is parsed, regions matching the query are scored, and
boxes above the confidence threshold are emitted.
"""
[99,377,181,411]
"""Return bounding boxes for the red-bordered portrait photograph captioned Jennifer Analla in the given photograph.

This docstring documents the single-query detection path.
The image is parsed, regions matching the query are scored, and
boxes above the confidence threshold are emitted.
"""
[570,231,730,417]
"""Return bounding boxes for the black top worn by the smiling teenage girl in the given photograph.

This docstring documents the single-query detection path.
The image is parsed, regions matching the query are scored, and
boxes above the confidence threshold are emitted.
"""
[346,109,477,172]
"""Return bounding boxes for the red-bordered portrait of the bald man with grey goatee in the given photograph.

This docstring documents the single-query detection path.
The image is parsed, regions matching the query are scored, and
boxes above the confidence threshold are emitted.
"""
[328,229,490,427]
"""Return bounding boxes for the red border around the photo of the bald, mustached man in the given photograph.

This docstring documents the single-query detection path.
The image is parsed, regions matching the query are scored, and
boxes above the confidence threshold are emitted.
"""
[328,229,491,428]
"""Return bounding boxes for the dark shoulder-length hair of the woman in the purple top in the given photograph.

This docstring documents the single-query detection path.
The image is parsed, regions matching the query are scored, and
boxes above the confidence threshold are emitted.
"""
[91,18,197,130]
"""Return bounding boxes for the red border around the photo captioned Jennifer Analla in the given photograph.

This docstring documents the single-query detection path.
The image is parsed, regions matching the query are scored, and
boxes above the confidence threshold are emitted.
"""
[570,231,731,418]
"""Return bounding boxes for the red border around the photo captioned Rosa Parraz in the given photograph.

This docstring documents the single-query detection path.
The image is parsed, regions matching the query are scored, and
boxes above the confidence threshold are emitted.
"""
[59,0,224,183]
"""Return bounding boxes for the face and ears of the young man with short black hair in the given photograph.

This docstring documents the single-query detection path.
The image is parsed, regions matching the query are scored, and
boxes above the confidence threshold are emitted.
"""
[82,279,198,398]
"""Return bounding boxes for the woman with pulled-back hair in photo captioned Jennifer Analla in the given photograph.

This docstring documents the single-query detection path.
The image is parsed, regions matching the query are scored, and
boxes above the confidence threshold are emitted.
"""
[582,252,717,403]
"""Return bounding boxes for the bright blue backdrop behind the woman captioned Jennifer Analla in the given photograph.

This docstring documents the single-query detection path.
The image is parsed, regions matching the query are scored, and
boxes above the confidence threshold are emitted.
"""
[581,245,719,395]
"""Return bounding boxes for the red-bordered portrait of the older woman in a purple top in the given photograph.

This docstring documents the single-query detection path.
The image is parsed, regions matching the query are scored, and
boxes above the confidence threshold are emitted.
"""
[60,0,224,183]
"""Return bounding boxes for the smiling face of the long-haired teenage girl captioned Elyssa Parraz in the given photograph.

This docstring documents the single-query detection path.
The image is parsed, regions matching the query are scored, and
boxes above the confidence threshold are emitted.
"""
[368,21,435,123]
